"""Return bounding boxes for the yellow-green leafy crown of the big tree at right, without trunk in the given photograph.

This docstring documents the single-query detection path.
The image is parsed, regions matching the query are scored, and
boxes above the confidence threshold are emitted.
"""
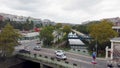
[89,20,118,43]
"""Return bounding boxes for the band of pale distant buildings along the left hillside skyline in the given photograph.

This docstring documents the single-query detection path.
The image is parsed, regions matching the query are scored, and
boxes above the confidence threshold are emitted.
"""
[0,13,55,26]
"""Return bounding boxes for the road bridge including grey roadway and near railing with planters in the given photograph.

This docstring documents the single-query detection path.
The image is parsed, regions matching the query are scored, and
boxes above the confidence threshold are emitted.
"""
[14,41,106,68]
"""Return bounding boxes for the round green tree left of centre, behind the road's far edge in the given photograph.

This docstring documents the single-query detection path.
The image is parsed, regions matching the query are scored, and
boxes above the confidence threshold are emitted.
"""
[40,26,54,45]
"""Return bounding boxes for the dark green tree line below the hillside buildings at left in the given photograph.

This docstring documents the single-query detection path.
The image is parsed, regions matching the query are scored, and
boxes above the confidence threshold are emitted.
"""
[0,20,43,31]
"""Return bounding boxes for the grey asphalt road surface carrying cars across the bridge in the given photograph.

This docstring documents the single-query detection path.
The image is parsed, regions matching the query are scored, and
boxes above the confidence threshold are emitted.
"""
[15,41,107,68]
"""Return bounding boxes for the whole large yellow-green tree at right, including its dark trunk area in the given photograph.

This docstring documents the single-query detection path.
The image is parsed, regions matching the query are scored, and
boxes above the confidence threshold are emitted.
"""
[88,20,118,56]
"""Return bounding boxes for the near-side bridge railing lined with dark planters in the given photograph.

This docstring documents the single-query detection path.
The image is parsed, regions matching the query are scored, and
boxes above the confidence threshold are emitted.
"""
[18,53,78,68]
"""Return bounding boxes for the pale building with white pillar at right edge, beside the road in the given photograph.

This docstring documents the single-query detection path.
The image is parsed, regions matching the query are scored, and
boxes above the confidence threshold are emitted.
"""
[106,37,120,61]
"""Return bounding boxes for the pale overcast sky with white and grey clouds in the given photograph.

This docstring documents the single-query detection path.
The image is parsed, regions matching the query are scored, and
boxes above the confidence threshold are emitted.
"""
[0,0,120,24]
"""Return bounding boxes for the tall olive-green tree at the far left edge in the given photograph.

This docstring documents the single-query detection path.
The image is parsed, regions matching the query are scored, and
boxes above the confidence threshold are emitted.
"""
[0,24,19,57]
